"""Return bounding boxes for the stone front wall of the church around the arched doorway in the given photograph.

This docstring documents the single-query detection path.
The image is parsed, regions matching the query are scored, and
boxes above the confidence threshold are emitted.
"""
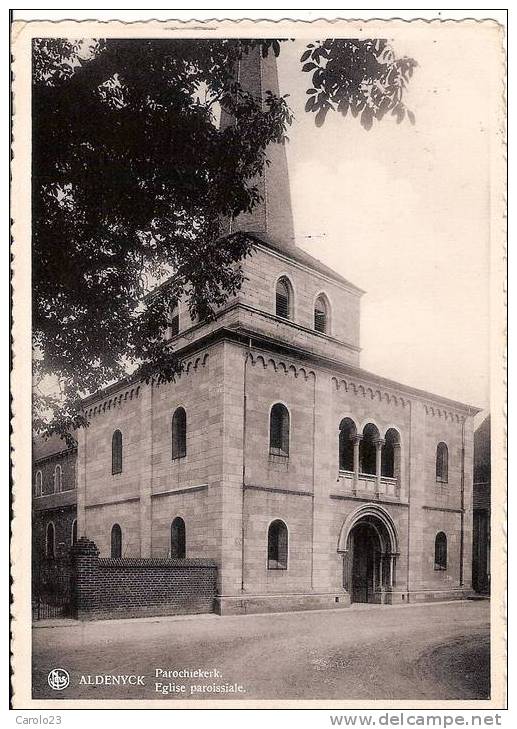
[221,336,472,600]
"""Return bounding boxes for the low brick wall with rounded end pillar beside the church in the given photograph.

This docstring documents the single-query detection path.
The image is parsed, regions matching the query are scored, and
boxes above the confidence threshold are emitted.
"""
[72,539,217,619]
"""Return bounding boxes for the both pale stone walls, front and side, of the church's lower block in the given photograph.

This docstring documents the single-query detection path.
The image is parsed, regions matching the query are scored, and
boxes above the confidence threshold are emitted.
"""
[74,322,472,598]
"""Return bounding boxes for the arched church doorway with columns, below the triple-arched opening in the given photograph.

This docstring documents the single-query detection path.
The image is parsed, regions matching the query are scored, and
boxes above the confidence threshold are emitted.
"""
[338,504,398,603]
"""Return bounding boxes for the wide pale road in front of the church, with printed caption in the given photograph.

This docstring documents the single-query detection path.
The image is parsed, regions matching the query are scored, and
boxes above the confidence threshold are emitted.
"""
[33,601,489,700]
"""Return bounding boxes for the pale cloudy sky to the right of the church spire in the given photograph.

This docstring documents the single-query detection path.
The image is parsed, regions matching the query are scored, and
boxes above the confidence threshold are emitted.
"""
[278,26,497,408]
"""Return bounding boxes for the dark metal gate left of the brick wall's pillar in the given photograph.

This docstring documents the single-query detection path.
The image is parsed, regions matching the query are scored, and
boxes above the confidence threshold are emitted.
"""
[32,557,72,620]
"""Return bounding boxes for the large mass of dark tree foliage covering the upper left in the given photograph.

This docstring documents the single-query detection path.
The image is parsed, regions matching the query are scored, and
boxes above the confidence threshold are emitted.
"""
[32,39,292,430]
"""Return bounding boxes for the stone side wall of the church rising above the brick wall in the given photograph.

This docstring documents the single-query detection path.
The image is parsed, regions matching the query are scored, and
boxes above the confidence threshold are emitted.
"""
[78,345,223,558]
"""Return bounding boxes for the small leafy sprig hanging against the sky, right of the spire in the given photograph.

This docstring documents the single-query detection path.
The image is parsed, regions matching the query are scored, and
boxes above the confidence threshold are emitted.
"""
[300,38,417,130]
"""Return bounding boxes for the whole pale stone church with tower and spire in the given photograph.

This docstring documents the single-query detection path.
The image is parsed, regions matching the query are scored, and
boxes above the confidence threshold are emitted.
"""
[77,47,478,614]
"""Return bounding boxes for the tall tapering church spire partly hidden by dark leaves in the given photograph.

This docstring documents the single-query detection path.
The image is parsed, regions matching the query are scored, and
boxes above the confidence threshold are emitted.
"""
[221,47,295,249]
